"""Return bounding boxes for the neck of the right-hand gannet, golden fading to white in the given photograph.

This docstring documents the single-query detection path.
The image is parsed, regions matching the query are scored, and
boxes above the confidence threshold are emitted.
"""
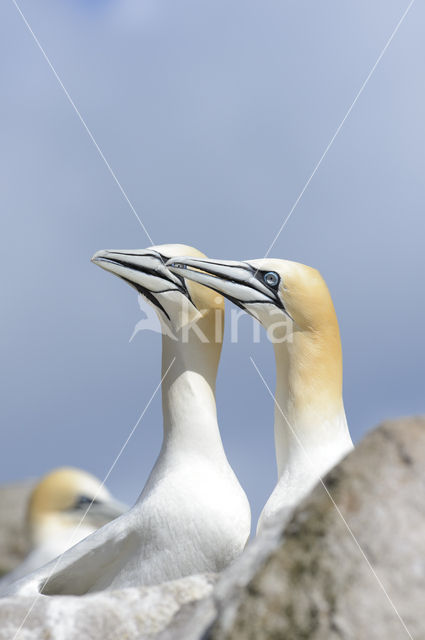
[274,329,352,503]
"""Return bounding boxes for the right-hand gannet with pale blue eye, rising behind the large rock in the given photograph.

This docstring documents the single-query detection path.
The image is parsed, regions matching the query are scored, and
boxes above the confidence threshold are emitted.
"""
[167,257,353,531]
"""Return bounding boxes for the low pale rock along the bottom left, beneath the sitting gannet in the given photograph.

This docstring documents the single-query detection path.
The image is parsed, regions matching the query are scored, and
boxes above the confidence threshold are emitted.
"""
[0,575,215,640]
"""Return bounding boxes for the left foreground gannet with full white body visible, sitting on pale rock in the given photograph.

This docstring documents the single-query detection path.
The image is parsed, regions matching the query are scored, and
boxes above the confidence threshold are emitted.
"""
[4,245,251,595]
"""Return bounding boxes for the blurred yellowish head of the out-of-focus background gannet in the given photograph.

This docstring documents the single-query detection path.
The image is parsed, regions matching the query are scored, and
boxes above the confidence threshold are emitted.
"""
[27,467,128,546]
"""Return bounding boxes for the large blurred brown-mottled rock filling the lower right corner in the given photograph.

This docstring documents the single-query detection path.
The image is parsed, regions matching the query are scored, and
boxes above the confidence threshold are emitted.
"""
[203,418,425,640]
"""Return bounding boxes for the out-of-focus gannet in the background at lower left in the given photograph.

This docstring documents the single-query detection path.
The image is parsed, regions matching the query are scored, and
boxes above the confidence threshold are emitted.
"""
[0,467,128,591]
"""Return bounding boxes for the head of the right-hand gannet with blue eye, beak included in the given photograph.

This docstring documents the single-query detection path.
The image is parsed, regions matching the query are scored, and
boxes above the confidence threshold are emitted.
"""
[167,256,336,331]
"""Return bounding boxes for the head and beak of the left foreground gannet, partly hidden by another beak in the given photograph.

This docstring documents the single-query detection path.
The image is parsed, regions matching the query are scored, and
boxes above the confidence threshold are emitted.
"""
[92,244,223,331]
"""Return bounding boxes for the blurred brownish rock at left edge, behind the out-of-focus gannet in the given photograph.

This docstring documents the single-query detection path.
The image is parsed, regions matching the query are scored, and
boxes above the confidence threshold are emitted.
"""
[0,481,34,575]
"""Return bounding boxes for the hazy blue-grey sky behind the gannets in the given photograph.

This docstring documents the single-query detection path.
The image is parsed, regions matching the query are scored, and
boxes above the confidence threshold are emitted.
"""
[0,0,425,521]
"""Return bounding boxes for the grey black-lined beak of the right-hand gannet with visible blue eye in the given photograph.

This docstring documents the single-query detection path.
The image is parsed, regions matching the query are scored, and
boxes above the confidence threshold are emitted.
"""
[166,257,285,315]
